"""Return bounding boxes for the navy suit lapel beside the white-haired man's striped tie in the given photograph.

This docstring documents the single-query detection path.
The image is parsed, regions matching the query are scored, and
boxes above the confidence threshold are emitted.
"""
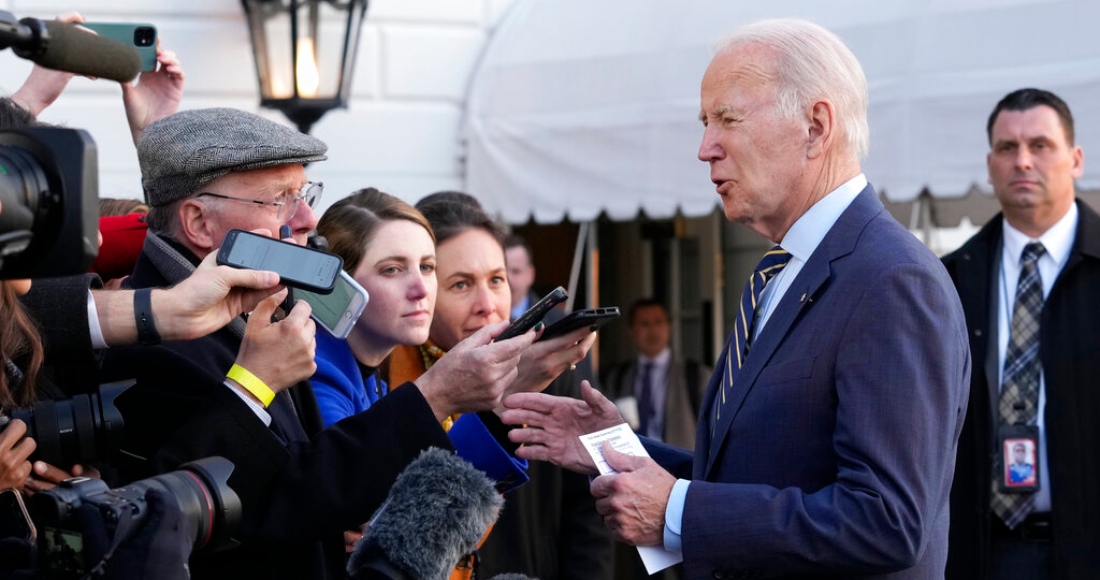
[696,185,883,482]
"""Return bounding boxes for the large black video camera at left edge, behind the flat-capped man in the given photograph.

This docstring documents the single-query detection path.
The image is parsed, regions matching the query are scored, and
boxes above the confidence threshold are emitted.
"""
[0,127,99,280]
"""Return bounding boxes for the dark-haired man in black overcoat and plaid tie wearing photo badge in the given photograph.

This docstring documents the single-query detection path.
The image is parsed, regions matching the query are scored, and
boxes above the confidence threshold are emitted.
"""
[944,88,1100,580]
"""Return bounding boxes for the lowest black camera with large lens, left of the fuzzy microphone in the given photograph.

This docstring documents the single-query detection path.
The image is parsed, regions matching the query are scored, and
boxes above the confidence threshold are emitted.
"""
[28,457,241,578]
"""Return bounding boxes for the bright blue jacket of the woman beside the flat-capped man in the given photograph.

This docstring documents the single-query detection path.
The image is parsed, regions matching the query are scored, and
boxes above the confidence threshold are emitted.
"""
[309,329,528,492]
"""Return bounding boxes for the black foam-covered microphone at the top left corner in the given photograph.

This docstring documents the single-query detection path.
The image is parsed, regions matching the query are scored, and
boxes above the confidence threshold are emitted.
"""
[0,18,141,83]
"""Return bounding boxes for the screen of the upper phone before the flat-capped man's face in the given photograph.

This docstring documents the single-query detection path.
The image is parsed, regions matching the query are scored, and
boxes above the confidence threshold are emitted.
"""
[226,232,342,288]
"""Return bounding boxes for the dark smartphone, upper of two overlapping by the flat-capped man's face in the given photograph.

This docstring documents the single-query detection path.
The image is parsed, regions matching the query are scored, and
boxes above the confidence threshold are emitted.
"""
[218,230,343,294]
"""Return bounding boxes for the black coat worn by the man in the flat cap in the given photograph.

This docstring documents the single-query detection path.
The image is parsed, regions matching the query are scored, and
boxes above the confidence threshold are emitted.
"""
[99,234,452,579]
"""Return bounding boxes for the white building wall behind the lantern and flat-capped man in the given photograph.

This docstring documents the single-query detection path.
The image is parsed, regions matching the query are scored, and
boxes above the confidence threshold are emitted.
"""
[0,0,513,207]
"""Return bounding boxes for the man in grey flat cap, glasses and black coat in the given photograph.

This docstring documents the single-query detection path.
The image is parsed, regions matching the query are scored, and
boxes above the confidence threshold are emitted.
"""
[107,109,534,579]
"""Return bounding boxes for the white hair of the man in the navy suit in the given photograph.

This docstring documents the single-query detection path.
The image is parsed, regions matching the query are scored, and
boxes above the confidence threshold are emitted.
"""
[715,19,871,160]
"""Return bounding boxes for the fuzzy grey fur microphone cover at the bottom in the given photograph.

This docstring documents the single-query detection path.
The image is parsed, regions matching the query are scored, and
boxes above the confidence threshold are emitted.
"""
[348,448,504,580]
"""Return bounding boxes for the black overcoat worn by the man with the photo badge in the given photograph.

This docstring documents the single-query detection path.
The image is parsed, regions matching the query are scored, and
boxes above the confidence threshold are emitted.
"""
[944,198,1100,580]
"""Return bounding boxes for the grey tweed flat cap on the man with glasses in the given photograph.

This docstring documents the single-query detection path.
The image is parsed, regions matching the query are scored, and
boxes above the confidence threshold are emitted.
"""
[138,109,328,206]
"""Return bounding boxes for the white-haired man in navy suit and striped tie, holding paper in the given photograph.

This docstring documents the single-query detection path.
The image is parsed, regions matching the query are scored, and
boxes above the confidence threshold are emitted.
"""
[505,20,970,579]
